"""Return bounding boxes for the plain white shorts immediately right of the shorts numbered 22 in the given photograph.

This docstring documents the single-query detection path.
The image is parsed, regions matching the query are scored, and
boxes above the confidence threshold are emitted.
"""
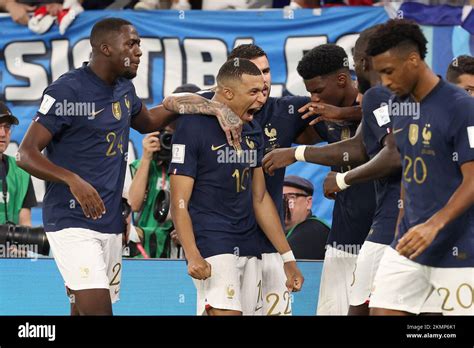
[316,245,357,315]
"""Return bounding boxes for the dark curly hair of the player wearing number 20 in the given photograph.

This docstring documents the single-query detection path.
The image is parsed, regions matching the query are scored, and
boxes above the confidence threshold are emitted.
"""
[366,19,428,59]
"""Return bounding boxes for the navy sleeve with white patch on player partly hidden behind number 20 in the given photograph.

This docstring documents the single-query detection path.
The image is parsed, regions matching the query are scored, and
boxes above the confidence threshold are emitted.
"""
[362,87,392,145]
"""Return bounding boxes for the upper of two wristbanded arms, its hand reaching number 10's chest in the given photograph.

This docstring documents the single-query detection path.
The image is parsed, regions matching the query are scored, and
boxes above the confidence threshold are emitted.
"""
[263,125,368,175]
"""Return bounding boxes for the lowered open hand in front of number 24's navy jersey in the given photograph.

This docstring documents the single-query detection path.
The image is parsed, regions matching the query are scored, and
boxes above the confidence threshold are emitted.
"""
[68,175,105,220]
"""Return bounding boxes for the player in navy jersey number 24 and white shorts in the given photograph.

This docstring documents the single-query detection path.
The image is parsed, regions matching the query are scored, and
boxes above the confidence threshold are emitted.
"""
[18,18,202,315]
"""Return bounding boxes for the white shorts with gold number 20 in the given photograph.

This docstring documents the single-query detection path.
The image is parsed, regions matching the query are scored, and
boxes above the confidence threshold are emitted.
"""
[369,248,474,315]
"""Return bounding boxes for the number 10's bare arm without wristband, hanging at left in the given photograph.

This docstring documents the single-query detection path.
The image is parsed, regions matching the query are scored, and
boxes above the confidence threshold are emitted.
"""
[170,175,211,279]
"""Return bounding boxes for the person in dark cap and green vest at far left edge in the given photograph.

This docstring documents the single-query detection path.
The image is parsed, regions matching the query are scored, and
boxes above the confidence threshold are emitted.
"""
[0,102,37,226]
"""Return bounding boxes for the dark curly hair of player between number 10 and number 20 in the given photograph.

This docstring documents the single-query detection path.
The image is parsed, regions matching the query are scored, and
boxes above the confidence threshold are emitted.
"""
[296,44,349,80]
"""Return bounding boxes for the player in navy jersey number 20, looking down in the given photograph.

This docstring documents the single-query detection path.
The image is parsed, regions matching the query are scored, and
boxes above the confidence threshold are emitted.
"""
[367,20,474,315]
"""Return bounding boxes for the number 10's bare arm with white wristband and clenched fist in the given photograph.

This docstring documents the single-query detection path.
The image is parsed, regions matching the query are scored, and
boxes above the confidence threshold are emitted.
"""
[252,168,304,291]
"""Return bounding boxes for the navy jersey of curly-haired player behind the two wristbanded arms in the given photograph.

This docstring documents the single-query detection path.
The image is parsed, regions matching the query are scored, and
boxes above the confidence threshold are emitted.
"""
[315,118,375,254]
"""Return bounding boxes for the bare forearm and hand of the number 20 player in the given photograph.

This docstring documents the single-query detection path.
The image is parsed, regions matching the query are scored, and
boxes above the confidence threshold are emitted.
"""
[396,161,474,259]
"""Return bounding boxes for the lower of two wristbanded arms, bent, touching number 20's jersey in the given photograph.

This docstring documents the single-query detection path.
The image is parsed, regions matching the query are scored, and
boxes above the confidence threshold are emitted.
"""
[323,134,402,198]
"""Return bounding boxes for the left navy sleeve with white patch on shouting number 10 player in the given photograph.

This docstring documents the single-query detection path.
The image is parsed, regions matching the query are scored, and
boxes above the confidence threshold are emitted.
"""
[168,115,201,178]
